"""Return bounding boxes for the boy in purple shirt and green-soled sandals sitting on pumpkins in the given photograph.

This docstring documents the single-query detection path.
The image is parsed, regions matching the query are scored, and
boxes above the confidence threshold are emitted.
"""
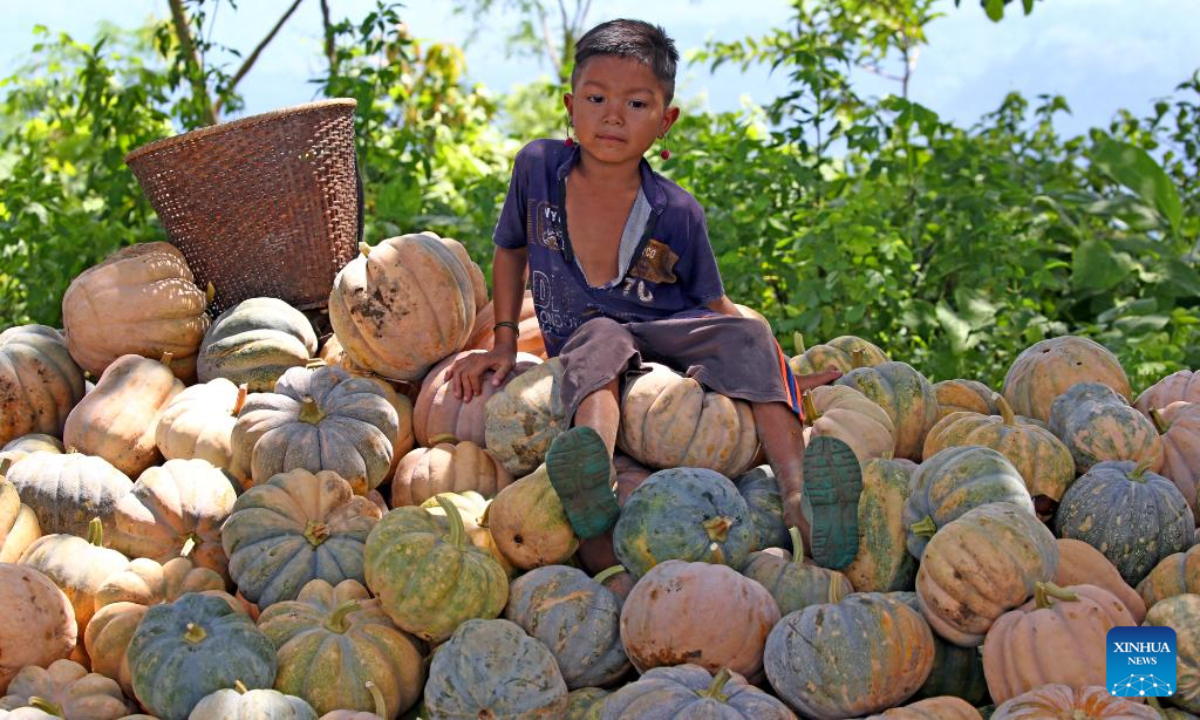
[450,19,862,568]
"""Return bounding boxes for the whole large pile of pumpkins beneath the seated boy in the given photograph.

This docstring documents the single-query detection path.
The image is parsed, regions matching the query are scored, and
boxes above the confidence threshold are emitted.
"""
[0,233,1200,720]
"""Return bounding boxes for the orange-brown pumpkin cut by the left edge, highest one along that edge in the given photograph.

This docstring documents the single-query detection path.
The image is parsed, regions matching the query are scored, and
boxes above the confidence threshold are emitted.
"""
[0,325,84,445]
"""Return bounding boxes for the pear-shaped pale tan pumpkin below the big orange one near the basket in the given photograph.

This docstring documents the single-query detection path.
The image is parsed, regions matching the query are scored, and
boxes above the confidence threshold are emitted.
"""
[62,355,184,476]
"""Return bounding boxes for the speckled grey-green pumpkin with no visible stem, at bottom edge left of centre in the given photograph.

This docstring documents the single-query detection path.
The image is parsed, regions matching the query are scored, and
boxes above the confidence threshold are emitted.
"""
[425,619,566,719]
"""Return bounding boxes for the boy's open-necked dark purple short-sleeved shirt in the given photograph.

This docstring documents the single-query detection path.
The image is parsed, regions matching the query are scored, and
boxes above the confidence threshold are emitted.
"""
[493,139,725,358]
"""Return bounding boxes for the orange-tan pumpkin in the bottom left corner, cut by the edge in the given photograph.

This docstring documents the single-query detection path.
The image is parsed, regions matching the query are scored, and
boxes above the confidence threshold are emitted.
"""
[0,660,128,720]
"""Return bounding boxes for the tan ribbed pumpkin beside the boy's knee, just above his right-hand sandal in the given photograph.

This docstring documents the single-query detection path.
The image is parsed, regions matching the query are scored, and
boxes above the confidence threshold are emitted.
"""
[804,385,895,463]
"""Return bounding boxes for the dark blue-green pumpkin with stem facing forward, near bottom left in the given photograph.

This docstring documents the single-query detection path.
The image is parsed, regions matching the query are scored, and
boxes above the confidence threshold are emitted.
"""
[126,593,278,720]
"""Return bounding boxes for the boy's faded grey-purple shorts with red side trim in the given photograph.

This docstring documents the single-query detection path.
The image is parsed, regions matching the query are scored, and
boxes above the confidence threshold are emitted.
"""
[558,313,803,419]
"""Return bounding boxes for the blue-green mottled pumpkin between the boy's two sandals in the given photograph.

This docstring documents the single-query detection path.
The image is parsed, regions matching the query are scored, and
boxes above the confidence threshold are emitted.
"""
[612,468,755,577]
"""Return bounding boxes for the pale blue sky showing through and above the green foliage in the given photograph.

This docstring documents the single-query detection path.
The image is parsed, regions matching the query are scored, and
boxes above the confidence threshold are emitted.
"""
[0,0,1200,134]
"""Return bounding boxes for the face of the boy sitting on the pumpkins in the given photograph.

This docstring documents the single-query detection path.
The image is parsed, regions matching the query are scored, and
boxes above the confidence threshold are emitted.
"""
[563,55,679,164]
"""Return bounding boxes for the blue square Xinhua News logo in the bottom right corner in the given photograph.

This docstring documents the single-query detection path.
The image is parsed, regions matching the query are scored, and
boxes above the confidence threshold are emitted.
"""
[1105,628,1176,697]
